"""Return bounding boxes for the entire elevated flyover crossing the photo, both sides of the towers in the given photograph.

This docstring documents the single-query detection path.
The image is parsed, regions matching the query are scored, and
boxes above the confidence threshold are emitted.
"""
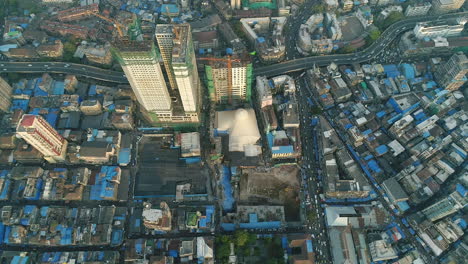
[0,12,468,84]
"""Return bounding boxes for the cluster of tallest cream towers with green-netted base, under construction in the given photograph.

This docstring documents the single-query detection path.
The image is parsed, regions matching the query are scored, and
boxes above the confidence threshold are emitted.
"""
[115,24,200,123]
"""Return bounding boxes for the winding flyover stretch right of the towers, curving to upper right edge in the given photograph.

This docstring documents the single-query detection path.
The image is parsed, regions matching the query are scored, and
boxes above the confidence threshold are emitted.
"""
[254,12,468,77]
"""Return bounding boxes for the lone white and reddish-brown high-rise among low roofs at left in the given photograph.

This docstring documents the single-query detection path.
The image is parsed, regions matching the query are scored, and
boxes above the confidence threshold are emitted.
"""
[16,115,68,163]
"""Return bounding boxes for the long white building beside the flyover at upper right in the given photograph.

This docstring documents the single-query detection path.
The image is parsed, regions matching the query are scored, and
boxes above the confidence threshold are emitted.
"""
[413,20,466,39]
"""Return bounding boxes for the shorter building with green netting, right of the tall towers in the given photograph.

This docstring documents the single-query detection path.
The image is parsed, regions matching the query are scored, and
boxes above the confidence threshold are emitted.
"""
[205,58,252,103]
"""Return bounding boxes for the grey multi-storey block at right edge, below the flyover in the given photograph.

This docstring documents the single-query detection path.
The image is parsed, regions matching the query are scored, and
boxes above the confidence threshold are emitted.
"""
[435,52,468,91]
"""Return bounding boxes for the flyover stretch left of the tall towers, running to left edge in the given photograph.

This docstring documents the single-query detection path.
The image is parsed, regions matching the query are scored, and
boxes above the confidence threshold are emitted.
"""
[0,61,128,84]
